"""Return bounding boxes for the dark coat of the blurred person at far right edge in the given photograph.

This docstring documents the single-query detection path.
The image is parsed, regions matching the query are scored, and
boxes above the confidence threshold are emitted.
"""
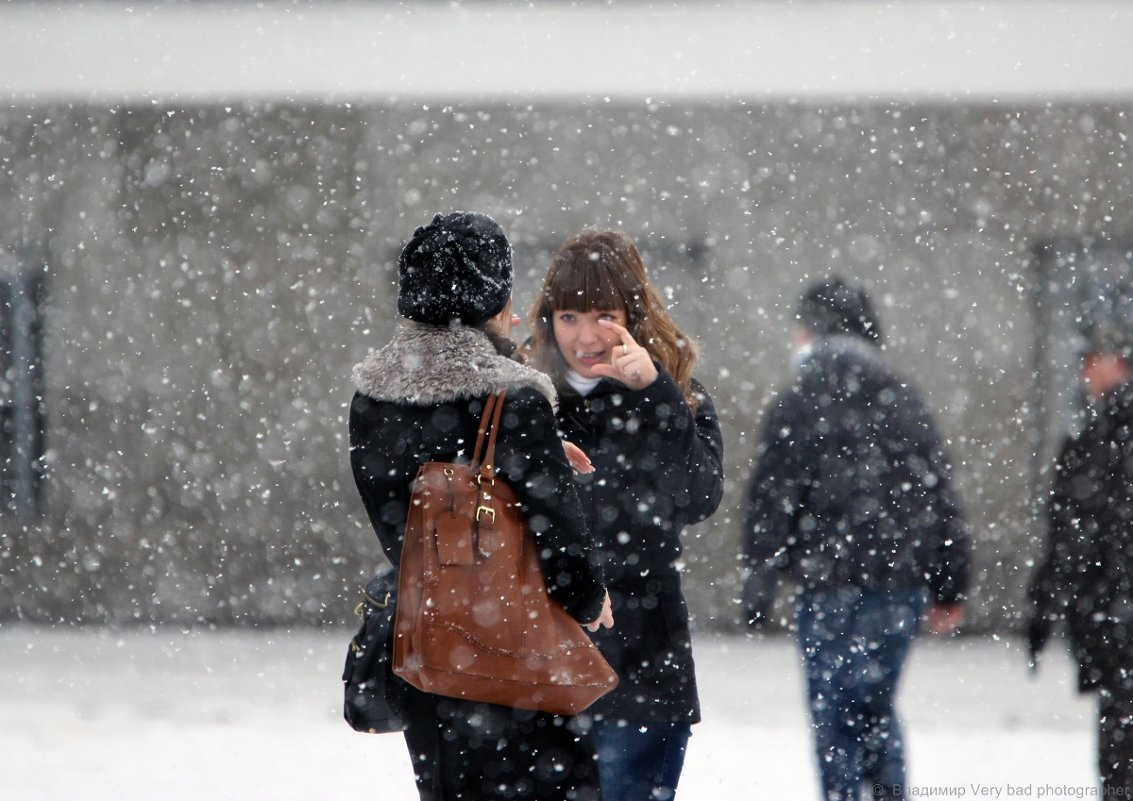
[1030,383,1133,691]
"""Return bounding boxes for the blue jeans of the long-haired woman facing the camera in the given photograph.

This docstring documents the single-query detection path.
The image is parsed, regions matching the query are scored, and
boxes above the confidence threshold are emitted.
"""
[594,721,692,801]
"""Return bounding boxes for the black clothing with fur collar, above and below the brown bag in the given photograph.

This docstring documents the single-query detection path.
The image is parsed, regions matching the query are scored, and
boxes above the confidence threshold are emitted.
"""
[350,323,605,801]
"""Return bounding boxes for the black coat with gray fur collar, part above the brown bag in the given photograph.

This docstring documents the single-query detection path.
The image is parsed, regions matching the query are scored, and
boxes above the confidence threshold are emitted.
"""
[350,323,605,623]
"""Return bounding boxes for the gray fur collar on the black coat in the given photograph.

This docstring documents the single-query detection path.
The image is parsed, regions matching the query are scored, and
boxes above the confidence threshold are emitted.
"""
[353,321,557,406]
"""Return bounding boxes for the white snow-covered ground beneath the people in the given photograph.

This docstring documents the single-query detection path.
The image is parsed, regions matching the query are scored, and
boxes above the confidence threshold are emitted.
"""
[0,625,1096,801]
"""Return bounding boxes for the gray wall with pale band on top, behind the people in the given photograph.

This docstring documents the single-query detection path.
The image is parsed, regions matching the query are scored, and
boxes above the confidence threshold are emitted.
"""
[0,0,1133,633]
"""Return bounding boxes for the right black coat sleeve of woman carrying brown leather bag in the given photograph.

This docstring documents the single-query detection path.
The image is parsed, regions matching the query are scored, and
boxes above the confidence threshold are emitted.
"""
[496,389,605,623]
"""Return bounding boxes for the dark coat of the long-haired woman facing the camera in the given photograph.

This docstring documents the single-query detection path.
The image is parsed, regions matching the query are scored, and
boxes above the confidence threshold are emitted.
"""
[557,369,724,723]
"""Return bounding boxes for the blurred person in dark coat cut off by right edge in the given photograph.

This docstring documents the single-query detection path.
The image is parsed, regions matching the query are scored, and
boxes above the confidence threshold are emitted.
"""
[1028,325,1133,798]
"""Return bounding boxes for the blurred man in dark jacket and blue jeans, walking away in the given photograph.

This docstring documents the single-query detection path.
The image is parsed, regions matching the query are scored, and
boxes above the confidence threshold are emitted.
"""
[744,279,968,801]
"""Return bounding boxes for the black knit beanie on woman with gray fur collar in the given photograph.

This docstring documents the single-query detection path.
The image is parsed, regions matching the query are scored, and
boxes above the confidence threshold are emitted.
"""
[398,212,512,326]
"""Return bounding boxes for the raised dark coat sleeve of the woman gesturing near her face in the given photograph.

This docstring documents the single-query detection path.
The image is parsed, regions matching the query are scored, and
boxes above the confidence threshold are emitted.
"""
[624,366,724,534]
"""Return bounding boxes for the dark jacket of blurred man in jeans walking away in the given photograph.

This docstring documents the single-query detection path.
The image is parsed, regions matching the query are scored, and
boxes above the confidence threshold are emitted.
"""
[744,335,969,603]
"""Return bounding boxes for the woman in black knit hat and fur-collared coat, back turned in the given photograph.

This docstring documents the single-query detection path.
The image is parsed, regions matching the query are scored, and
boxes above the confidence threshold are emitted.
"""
[350,212,613,801]
